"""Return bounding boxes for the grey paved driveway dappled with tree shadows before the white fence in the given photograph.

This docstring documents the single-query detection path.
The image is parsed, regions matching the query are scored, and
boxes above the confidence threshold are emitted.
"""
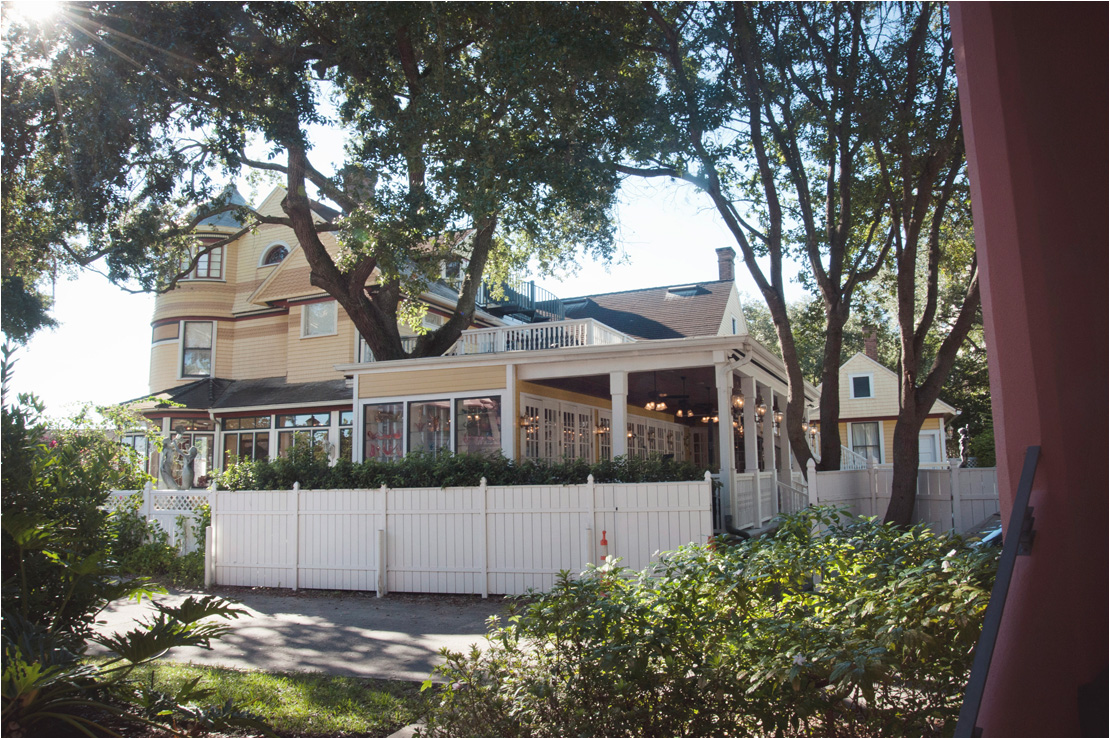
[91,587,506,680]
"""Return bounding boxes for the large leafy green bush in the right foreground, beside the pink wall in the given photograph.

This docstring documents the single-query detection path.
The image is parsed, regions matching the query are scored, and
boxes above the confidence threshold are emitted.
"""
[426,508,998,737]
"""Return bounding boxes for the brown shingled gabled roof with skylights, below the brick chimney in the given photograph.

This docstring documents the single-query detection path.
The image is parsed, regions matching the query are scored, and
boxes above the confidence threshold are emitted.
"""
[563,280,734,340]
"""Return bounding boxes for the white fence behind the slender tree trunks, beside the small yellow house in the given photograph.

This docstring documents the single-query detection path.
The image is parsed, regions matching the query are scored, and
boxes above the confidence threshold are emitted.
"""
[809,462,999,533]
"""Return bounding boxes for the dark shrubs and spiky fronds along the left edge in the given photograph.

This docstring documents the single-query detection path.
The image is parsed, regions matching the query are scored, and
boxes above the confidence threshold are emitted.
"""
[0,348,264,737]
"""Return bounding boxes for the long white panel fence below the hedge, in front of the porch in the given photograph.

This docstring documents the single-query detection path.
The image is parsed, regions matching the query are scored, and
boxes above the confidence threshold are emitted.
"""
[205,475,713,596]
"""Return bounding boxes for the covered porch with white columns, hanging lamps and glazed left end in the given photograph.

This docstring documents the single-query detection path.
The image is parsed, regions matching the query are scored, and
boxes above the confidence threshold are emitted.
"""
[336,323,816,530]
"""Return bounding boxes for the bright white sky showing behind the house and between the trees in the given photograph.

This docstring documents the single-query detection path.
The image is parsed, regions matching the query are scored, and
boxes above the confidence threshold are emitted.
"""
[11,175,803,417]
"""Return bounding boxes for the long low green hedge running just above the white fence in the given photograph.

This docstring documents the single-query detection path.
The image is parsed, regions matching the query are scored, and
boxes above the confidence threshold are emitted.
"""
[218,446,705,489]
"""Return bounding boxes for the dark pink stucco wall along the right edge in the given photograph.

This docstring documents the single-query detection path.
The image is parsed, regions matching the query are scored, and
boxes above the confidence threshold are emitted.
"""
[951,2,1110,738]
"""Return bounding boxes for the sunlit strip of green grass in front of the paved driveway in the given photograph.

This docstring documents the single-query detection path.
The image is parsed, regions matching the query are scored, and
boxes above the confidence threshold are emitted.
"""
[123,661,426,738]
